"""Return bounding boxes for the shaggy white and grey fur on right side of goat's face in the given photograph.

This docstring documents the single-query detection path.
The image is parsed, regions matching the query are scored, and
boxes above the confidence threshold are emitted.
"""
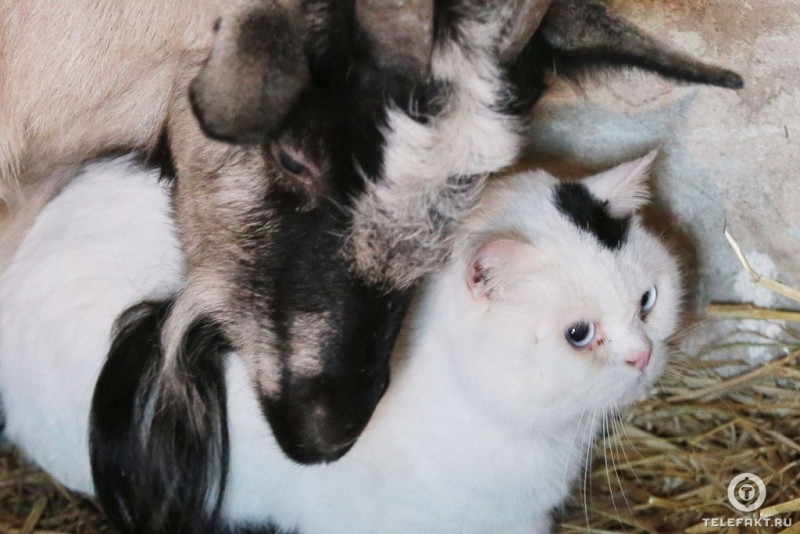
[348,16,522,287]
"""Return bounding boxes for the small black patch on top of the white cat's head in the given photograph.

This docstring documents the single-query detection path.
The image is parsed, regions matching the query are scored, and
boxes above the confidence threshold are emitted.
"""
[555,183,631,250]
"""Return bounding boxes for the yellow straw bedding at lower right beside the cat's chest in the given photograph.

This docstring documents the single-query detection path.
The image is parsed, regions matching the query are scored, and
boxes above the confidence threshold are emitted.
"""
[561,324,800,533]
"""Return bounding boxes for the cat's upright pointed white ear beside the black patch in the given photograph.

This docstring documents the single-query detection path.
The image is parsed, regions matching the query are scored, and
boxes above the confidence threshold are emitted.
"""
[583,150,658,217]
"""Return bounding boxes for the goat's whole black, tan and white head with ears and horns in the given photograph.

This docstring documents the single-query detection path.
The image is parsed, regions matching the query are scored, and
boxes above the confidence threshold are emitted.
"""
[108,0,741,462]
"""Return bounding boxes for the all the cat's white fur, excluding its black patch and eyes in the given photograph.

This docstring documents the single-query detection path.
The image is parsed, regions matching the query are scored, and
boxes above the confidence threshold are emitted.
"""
[0,155,679,533]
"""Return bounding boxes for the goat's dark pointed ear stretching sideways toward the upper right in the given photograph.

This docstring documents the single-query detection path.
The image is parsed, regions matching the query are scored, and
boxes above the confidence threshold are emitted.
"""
[535,0,744,89]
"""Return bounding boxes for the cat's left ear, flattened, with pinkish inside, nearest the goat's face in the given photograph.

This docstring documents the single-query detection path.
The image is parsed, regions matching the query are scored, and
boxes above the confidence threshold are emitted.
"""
[467,239,536,300]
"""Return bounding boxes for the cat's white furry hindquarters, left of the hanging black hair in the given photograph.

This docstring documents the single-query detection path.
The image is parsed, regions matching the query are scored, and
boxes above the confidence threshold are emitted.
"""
[0,158,183,491]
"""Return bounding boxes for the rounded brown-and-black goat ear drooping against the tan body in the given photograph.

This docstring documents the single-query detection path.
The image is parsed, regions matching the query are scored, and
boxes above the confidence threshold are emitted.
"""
[189,0,310,143]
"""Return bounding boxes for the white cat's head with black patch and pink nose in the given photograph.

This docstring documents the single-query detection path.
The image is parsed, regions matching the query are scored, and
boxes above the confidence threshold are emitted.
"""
[436,153,681,430]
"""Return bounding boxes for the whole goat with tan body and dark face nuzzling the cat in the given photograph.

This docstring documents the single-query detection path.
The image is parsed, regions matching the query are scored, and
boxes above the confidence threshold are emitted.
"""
[0,0,741,468]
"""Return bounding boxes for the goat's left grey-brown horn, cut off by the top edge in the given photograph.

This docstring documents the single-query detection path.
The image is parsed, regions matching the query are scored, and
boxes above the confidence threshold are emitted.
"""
[355,0,433,75]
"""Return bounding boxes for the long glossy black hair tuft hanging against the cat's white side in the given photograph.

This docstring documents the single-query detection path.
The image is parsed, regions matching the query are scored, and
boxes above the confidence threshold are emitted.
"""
[90,301,234,533]
